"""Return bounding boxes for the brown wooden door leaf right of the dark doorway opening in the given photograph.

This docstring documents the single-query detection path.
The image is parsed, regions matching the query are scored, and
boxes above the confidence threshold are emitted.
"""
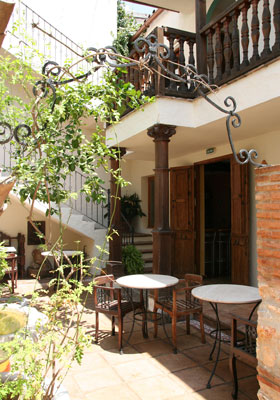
[231,157,249,285]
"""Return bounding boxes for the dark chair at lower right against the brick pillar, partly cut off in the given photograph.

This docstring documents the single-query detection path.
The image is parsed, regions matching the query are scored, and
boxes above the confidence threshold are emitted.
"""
[229,317,257,399]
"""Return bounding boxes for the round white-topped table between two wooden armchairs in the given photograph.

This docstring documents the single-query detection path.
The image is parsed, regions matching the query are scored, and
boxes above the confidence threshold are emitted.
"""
[116,274,179,342]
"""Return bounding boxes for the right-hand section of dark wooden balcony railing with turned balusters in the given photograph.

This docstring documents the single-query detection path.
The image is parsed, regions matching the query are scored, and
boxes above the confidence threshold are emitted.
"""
[200,0,280,85]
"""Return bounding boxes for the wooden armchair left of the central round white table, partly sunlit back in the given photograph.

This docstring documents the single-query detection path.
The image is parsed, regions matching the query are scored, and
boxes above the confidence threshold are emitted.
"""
[93,275,144,353]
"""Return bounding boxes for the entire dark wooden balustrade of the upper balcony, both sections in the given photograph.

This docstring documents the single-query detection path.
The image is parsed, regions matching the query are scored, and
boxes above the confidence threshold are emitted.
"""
[124,0,280,98]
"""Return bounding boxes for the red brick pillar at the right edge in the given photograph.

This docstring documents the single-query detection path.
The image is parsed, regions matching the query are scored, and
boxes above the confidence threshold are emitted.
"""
[256,165,280,400]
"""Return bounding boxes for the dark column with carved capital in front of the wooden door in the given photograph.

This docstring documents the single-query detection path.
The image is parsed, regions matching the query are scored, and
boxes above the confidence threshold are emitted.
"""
[148,124,176,275]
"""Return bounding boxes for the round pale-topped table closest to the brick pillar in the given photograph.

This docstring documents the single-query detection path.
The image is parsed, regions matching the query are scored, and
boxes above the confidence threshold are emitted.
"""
[192,284,261,389]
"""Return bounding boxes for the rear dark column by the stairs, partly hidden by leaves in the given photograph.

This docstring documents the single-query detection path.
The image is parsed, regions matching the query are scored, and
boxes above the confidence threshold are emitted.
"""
[109,147,126,261]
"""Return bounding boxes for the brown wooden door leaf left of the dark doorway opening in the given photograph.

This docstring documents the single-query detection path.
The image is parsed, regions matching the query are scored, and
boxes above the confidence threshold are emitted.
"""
[170,166,195,277]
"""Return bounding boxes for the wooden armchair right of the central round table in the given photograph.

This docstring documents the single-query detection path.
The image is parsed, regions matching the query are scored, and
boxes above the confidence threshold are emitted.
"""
[154,274,205,354]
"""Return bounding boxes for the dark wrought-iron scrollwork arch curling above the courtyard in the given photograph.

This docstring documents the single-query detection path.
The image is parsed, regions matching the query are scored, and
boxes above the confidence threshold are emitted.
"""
[0,34,267,167]
